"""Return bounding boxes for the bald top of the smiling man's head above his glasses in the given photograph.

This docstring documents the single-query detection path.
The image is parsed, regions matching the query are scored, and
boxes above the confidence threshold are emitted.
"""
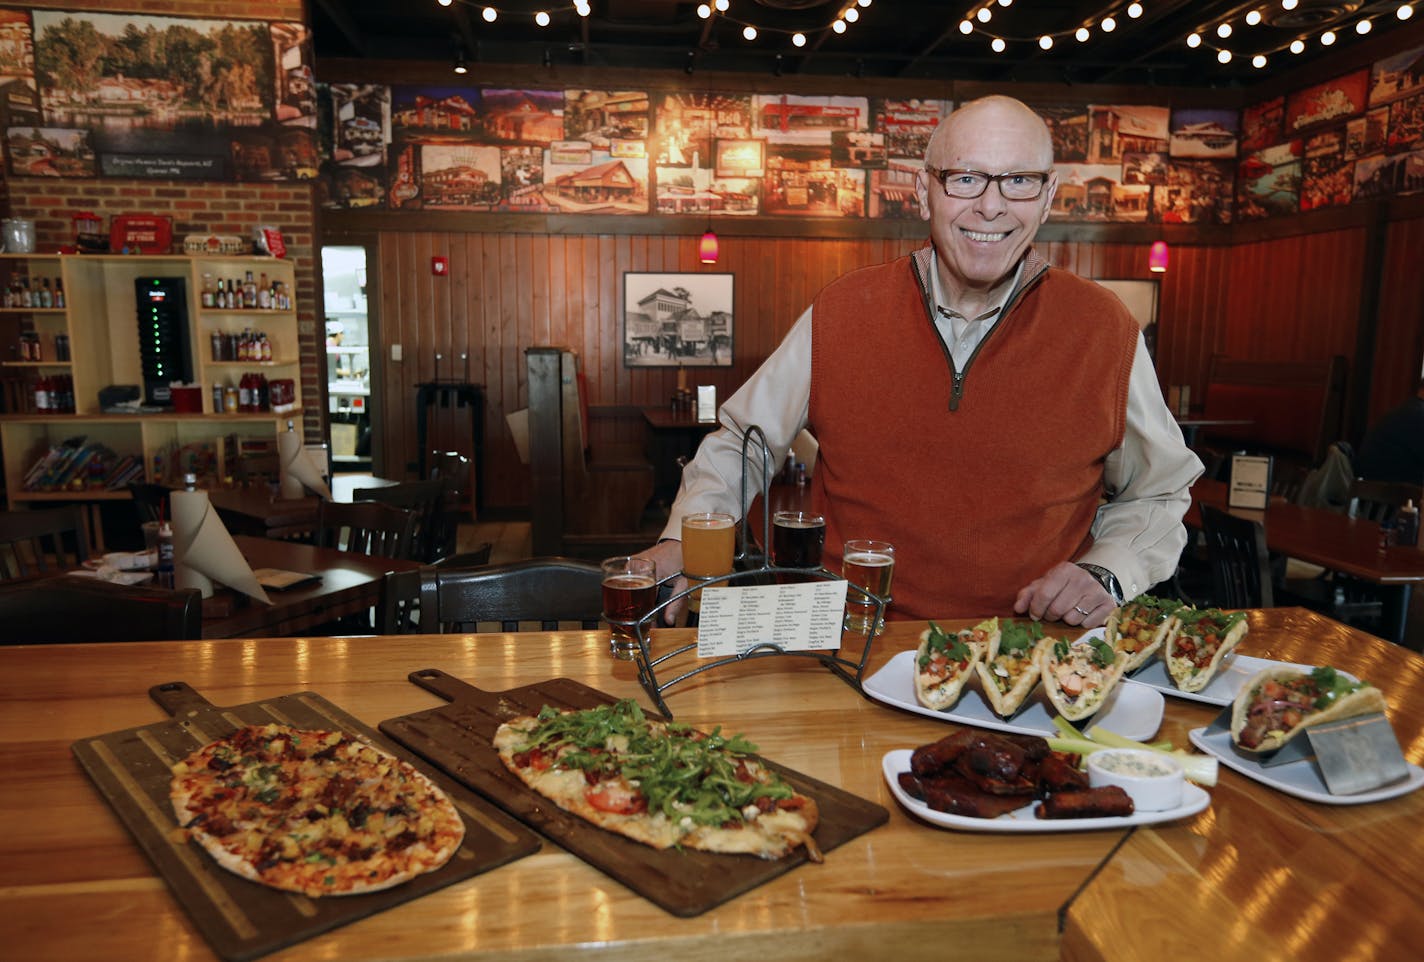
[924,94,1054,174]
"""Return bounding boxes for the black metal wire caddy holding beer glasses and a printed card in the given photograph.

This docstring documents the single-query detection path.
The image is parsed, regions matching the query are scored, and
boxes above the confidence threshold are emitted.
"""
[608,424,890,719]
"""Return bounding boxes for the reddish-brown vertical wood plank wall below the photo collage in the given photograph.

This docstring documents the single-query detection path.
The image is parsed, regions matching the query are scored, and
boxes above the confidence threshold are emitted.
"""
[373,219,1424,508]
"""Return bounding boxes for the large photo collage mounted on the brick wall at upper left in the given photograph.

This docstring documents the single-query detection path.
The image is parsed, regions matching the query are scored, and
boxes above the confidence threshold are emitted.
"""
[0,9,320,181]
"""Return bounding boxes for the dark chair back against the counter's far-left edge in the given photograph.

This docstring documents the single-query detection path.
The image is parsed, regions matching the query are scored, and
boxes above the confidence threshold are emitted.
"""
[0,578,202,645]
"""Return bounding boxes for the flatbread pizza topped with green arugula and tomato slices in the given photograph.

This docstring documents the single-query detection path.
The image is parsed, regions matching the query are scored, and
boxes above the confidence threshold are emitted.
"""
[494,699,820,861]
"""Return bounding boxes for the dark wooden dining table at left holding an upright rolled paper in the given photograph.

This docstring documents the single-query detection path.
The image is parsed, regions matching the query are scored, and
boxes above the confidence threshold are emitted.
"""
[202,535,420,638]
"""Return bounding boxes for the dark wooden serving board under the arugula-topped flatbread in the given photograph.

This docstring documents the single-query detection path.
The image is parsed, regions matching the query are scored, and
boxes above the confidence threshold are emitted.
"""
[380,669,890,918]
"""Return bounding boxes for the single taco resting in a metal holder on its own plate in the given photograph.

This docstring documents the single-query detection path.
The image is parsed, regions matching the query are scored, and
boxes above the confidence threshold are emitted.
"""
[1232,665,1387,751]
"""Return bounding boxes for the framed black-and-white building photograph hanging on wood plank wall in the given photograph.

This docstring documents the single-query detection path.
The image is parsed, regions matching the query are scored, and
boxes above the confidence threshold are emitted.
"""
[624,270,733,367]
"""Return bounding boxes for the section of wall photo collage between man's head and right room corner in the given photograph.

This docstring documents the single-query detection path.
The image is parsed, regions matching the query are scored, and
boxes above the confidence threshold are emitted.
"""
[1034,104,1239,223]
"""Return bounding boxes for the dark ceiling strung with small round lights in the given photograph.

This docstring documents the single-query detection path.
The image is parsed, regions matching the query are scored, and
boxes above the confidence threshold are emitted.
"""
[310,0,1424,87]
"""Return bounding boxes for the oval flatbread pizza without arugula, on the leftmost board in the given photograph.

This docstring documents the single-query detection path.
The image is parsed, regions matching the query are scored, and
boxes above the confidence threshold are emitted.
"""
[168,724,464,897]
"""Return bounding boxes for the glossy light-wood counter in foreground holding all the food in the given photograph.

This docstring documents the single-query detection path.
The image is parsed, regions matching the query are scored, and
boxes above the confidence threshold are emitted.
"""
[0,609,1424,962]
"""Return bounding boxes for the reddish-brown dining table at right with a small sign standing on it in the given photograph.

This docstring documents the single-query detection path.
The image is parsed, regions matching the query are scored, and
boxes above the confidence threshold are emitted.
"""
[1183,478,1424,643]
